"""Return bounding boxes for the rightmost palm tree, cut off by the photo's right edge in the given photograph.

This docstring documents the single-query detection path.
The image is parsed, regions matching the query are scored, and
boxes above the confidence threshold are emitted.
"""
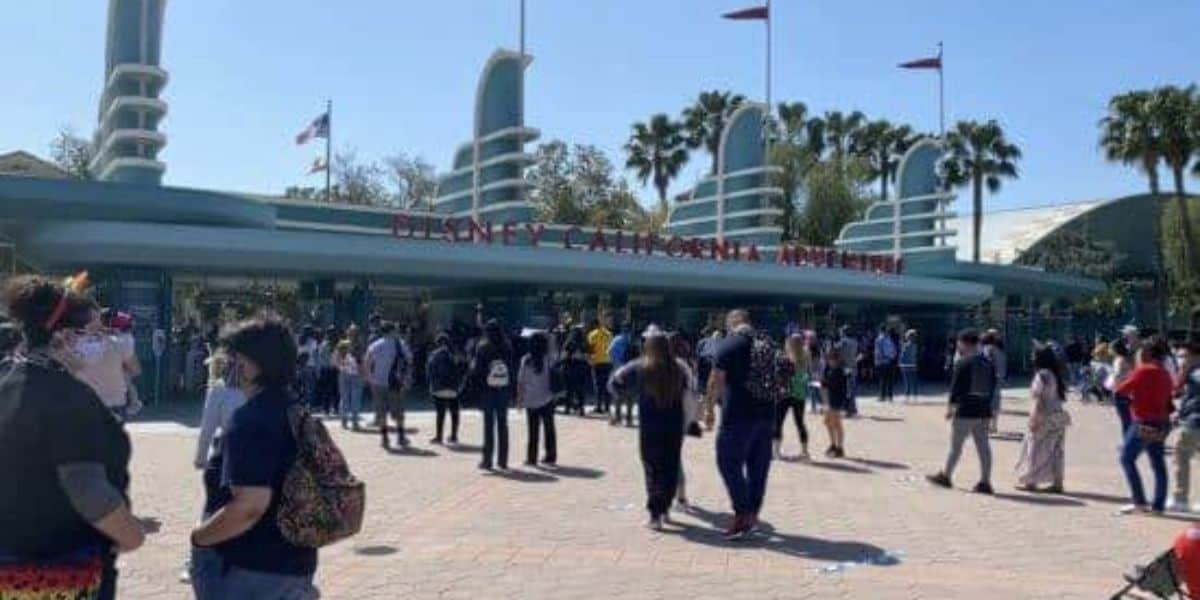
[1147,85,1200,272]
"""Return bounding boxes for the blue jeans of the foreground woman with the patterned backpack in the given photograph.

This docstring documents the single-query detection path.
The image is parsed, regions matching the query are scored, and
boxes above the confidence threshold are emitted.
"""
[191,548,320,600]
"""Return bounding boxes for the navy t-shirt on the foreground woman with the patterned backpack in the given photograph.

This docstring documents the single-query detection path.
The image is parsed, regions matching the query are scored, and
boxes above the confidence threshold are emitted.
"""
[214,388,317,576]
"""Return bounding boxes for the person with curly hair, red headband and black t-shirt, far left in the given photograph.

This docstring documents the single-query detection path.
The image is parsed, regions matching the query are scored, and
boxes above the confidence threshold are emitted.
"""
[0,276,157,600]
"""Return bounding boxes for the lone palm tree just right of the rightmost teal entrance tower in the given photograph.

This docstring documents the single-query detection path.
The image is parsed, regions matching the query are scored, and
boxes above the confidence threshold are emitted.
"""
[942,120,1021,263]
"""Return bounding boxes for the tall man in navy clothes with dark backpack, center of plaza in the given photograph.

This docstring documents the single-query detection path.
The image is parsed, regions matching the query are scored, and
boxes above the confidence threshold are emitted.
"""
[708,310,780,540]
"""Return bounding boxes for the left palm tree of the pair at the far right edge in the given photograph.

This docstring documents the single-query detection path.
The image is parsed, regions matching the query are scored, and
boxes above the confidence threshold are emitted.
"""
[1100,91,1162,196]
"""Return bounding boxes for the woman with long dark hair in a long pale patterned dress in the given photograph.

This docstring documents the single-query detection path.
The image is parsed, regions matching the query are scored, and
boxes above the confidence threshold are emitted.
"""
[1016,347,1070,493]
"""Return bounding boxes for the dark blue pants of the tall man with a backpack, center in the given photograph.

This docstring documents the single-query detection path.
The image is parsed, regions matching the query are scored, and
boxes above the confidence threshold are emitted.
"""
[716,416,775,516]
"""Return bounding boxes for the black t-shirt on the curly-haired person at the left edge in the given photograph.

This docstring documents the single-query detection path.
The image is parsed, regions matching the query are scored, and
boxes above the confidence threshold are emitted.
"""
[0,358,130,558]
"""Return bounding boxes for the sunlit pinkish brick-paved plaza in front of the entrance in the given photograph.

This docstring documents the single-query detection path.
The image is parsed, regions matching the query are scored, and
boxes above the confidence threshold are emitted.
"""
[120,389,1187,600]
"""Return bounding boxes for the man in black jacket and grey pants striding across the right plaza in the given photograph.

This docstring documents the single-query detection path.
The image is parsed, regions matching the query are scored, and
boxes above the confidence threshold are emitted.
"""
[925,329,996,496]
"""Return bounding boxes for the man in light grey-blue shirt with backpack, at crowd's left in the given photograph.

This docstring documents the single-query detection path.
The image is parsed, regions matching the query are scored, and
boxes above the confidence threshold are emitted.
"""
[365,323,413,449]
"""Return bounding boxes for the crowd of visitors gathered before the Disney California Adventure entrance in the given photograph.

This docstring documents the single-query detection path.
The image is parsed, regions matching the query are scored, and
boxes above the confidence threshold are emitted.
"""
[0,268,1200,599]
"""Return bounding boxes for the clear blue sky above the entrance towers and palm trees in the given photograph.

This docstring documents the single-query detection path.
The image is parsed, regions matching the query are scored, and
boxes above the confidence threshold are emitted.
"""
[0,0,1200,213]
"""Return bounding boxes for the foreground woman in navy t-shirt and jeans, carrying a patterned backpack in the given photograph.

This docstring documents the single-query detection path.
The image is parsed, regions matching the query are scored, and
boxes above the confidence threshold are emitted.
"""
[191,317,319,600]
